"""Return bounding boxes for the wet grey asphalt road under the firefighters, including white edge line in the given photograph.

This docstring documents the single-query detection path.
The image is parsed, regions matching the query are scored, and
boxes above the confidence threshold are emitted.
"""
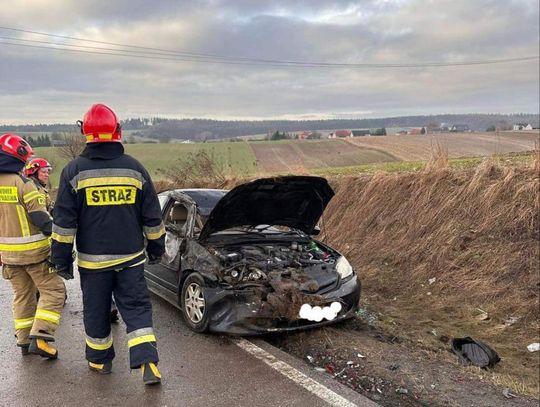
[0,270,374,407]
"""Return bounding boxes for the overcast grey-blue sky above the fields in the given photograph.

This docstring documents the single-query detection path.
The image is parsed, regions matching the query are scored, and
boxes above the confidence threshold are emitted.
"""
[0,0,539,124]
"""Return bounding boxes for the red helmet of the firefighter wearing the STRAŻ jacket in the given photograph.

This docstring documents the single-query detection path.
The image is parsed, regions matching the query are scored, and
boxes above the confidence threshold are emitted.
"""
[77,103,122,143]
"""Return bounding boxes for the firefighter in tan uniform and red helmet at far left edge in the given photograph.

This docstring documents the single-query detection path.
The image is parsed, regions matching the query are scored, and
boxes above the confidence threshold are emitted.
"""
[0,134,65,359]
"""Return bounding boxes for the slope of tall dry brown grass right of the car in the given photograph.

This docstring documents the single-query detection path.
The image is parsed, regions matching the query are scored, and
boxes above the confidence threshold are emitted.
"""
[314,161,540,397]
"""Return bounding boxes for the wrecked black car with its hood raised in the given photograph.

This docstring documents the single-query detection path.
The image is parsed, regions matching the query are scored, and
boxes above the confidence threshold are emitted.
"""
[145,176,360,335]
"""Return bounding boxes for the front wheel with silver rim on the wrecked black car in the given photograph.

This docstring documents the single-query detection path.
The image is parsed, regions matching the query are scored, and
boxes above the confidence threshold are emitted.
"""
[180,272,209,333]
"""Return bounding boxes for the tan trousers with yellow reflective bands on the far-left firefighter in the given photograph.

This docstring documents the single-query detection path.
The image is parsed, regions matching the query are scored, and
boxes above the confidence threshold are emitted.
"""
[2,261,66,346]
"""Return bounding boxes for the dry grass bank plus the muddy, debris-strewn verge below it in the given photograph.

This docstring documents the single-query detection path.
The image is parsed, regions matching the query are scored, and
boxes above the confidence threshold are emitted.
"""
[158,152,540,406]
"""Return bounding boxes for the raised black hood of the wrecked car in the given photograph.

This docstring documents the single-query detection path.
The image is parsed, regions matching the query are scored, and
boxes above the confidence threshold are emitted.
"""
[199,176,334,239]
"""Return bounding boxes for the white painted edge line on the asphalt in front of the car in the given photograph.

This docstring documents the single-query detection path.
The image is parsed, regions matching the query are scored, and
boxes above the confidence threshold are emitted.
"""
[232,338,357,407]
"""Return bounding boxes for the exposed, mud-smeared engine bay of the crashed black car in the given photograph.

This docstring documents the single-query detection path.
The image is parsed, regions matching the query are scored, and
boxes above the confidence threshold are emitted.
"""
[207,239,341,320]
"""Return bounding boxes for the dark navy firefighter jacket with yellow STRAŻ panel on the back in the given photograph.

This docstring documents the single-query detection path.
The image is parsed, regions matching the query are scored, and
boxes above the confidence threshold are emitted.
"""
[51,143,165,272]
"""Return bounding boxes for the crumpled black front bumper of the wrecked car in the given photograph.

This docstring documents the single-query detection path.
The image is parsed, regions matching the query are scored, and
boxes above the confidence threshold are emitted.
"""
[200,274,361,335]
